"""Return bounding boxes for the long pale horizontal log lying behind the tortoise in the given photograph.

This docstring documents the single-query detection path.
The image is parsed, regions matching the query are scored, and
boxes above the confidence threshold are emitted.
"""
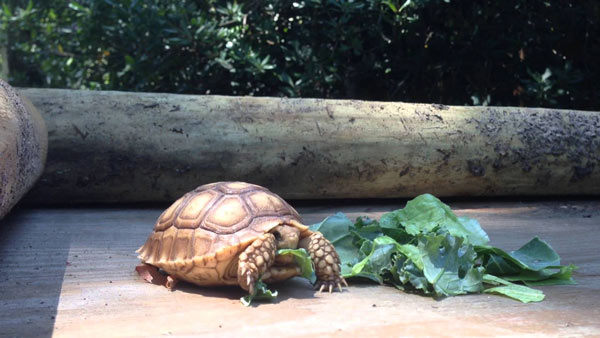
[17,89,600,203]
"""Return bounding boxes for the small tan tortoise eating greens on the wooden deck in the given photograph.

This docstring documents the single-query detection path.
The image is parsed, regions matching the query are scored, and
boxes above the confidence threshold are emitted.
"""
[137,182,348,293]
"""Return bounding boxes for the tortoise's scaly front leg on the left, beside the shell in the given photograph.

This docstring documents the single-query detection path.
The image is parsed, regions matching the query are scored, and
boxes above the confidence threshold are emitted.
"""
[238,233,276,294]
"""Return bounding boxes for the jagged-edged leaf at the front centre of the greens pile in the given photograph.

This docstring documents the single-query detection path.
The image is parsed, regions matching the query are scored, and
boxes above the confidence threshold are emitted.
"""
[418,233,484,296]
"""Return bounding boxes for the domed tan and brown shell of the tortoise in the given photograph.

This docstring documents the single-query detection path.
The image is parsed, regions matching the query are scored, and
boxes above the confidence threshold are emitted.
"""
[137,182,310,285]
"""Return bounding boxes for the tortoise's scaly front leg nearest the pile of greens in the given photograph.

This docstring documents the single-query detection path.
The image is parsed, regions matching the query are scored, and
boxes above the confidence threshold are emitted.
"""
[298,232,348,293]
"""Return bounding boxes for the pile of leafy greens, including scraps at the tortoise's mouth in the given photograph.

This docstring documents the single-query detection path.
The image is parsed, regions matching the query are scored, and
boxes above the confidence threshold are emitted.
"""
[241,194,577,303]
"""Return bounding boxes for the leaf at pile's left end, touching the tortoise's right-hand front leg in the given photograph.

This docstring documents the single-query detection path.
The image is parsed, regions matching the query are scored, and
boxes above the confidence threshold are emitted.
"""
[310,212,360,276]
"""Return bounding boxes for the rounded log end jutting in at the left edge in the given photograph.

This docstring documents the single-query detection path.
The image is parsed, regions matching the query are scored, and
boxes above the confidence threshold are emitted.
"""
[0,79,48,219]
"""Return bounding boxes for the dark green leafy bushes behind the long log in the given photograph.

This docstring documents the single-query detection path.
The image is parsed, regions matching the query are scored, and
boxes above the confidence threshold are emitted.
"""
[0,0,600,110]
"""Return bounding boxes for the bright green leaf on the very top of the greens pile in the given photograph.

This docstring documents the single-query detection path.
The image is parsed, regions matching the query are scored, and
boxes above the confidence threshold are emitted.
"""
[379,194,490,245]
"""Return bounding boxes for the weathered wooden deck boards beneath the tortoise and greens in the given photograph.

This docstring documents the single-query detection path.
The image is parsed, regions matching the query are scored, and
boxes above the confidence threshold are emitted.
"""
[0,200,600,337]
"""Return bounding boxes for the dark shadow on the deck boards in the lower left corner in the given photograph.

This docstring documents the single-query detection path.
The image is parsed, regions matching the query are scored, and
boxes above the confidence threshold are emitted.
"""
[0,209,71,337]
